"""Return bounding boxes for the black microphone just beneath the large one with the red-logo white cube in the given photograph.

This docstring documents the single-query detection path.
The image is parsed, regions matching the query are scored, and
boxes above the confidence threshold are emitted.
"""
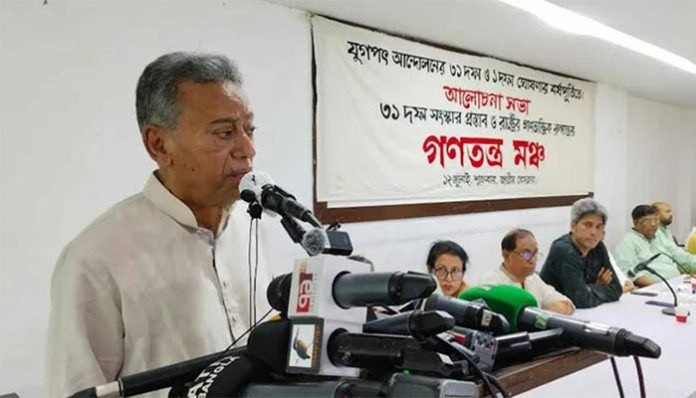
[363,310,454,340]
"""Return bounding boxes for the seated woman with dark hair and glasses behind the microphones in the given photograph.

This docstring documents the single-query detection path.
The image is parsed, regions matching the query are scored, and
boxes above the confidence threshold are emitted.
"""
[426,240,469,297]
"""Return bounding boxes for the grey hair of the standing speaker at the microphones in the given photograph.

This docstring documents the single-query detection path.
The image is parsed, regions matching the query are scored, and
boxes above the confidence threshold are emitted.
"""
[135,52,242,132]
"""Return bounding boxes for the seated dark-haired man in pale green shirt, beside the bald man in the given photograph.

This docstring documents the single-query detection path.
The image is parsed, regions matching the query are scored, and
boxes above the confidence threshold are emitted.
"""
[614,205,696,287]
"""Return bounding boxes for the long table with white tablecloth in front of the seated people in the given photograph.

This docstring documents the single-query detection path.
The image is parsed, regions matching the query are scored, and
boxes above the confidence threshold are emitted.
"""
[517,277,696,398]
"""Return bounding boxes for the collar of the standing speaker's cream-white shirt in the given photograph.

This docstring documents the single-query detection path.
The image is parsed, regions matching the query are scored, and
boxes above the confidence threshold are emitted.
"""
[143,172,234,235]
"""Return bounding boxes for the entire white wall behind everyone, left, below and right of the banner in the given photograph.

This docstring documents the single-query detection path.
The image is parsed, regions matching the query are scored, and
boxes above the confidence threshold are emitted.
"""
[0,0,696,397]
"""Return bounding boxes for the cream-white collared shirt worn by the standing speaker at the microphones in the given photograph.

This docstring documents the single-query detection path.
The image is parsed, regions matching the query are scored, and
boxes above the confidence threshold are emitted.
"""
[46,174,269,397]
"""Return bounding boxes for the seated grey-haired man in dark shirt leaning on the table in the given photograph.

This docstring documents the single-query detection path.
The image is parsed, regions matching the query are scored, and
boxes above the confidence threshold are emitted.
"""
[541,198,621,308]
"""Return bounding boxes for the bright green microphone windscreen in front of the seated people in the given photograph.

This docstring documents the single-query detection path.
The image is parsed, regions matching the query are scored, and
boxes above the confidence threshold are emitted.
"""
[459,285,538,331]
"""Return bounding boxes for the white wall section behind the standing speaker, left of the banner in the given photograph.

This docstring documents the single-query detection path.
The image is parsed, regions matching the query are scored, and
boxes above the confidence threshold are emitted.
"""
[0,0,312,397]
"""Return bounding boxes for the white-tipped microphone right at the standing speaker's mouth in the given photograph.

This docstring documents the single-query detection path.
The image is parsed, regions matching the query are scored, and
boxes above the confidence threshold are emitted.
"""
[239,170,321,228]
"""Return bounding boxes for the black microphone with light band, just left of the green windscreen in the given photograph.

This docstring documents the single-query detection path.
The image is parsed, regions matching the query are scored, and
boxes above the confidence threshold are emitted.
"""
[423,294,510,335]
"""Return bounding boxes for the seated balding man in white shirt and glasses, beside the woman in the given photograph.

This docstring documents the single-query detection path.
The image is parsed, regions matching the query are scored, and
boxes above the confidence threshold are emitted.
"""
[482,228,575,315]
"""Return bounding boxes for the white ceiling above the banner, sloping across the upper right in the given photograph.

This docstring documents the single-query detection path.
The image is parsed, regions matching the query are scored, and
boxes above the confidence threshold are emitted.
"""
[268,0,696,107]
